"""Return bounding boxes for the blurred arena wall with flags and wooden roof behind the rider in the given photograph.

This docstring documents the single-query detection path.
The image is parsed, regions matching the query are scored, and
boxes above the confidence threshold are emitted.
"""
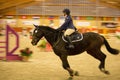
[0,0,120,52]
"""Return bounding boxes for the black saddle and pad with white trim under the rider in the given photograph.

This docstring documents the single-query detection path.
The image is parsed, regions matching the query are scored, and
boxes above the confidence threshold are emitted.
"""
[62,31,83,42]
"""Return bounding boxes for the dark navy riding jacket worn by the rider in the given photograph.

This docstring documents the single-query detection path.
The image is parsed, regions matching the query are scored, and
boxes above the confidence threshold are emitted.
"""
[57,15,76,31]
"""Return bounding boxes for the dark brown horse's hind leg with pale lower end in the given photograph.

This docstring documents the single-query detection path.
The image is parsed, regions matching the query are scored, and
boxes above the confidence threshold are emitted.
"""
[87,49,109,74]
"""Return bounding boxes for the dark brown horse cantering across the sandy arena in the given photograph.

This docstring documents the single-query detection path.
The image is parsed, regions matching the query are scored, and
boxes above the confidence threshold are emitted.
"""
[31,25,119,80]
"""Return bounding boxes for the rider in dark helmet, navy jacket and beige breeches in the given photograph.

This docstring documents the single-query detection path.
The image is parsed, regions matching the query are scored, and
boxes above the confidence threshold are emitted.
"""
[57,8,76,49]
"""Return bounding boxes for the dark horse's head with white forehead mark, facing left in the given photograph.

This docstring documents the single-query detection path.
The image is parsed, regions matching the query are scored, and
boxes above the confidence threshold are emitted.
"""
[31,25,44,45]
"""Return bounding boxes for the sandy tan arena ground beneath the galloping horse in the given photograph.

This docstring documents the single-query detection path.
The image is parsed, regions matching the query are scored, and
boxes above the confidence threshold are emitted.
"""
[0,36,120,80]
